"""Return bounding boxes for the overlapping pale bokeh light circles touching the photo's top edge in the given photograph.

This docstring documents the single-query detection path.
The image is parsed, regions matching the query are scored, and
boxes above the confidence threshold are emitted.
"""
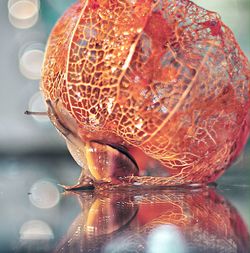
[8,0,40,29]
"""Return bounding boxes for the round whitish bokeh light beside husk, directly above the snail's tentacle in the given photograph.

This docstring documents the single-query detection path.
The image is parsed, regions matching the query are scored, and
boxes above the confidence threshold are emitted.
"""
[19,43,44,80]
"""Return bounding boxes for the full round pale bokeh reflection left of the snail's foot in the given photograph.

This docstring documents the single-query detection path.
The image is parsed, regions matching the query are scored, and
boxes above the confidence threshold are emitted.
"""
[29,180,60,209]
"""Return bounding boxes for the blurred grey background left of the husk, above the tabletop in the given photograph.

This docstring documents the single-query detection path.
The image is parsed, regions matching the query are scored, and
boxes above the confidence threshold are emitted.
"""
[0,0,77,154]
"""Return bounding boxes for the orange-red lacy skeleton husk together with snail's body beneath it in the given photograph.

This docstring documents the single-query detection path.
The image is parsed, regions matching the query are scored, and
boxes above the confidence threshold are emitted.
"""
[41,0,250,187]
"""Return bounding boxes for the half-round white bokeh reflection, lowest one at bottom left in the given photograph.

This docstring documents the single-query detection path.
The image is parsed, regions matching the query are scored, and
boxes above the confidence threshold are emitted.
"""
[19,220,54,240]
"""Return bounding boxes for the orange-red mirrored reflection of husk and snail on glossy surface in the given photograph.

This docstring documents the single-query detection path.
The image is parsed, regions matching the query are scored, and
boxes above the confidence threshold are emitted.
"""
[56,189,250,253]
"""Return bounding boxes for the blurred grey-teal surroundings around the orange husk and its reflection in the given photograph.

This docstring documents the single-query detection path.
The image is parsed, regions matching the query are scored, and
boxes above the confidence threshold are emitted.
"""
[0,0,250,252]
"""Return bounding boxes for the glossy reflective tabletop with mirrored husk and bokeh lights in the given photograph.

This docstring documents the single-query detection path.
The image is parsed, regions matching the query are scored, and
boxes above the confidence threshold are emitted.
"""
[0,150,250,253]
